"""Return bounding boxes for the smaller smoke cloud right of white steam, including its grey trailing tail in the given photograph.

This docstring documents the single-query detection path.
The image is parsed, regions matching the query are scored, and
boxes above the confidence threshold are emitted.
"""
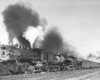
[35,27,77,57]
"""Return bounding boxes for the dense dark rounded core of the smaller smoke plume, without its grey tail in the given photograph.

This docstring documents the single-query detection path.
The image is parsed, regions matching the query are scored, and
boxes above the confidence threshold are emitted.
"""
[41,27,63,53]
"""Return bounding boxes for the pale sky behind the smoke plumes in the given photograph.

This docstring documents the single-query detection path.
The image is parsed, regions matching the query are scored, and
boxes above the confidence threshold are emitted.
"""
[0,0,100,57]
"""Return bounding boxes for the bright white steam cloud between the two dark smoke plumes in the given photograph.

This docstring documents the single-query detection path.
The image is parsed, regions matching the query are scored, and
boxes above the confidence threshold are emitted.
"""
[23,26,43,48]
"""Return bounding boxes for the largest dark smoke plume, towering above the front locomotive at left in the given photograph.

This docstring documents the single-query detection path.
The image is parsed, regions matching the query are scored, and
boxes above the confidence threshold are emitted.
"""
[2,4,40,46]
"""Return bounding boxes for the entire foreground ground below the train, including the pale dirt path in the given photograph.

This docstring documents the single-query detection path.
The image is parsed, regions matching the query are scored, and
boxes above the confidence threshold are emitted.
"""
[0,68,100,80]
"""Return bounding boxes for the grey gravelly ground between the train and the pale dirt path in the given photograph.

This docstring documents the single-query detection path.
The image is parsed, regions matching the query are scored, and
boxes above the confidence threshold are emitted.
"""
[0,68,100,80]
